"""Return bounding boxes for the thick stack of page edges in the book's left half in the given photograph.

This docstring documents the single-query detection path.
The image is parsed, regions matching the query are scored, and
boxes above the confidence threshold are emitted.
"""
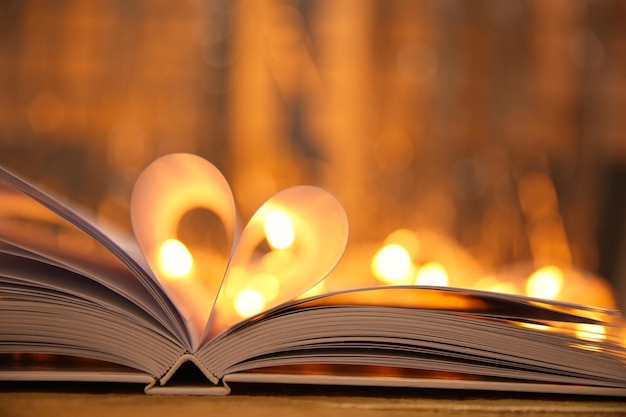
[0,279,186,379]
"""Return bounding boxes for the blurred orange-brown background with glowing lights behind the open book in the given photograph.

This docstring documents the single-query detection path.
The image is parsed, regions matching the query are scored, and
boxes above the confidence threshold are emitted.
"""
[0,0,626,308]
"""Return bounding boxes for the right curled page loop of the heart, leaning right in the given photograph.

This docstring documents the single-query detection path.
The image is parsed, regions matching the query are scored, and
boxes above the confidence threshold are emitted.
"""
[204,186,348,343]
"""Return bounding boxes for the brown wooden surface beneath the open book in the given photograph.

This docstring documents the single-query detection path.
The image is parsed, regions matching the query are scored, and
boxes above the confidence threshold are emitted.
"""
[0,383,626,417]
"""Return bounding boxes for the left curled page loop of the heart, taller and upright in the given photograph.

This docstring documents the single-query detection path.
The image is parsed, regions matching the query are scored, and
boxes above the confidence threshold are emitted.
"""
[131,154,237,349]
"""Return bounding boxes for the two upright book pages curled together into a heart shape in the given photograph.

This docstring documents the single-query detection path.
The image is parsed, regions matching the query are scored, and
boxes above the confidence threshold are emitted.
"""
[131,154,348,349]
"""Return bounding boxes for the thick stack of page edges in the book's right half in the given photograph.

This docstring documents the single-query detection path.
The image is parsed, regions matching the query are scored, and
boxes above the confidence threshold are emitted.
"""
[207,307,626,386]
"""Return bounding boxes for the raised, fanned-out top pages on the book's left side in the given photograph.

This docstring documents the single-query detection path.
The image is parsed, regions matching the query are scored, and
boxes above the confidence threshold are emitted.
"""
[0,168,188,340]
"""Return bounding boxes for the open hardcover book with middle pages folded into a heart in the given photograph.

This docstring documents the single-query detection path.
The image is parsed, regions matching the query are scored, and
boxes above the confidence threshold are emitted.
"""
[0,154,626,396]
